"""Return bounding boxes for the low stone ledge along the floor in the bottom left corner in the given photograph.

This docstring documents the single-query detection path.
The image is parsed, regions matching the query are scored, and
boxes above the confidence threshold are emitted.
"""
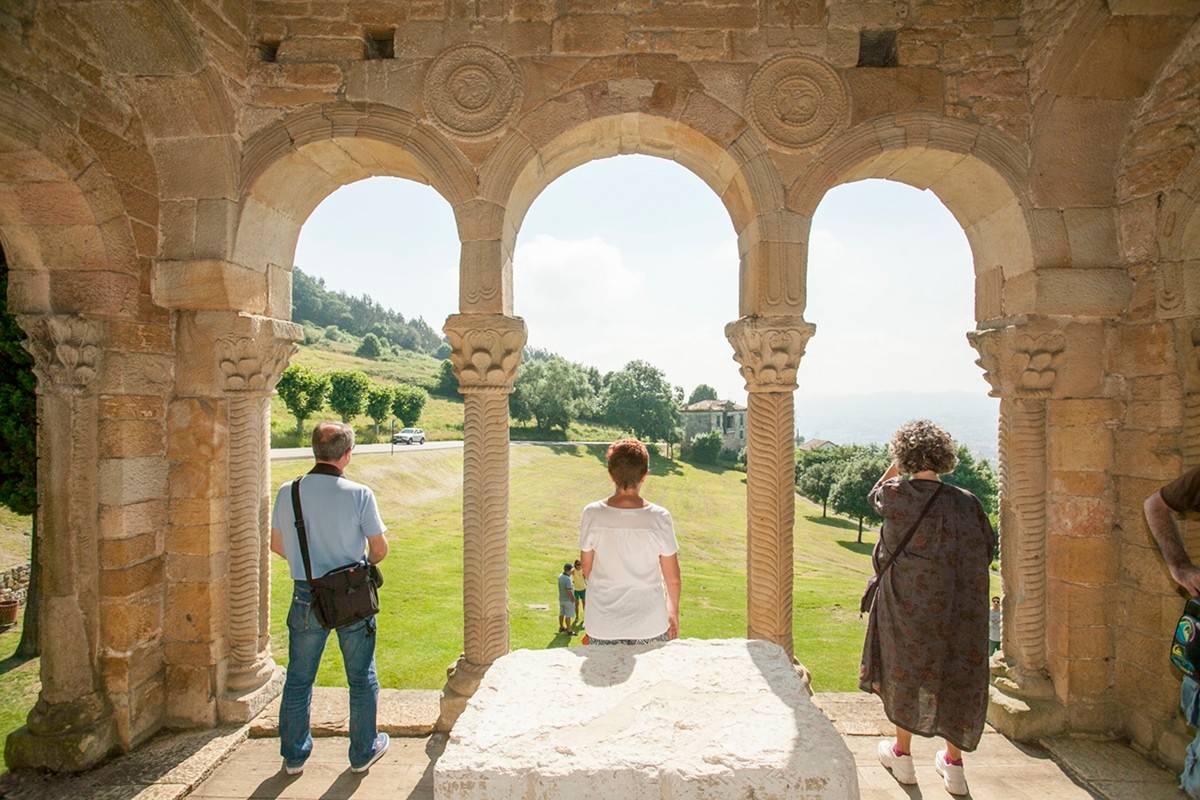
[0,726,248,800]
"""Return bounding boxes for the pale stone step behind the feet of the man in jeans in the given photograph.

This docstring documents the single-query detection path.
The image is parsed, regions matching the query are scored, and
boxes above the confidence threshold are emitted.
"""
[250,686,442,739]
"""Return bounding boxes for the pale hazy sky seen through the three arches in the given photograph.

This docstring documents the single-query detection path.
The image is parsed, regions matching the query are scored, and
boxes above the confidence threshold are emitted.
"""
[295,156,986,399]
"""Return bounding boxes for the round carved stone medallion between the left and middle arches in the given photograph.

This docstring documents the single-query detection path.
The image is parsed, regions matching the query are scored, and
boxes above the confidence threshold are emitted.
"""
[425,44,524,139]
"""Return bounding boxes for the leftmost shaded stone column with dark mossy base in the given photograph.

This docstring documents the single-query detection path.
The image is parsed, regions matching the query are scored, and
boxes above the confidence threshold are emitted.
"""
[5,315,116,771]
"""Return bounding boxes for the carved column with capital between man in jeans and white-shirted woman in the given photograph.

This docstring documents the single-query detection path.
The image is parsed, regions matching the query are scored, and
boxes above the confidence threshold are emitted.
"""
[438,314,526,730]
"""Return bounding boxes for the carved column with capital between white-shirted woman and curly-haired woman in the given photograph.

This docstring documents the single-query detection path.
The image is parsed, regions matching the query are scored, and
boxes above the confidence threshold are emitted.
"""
[725,317,816,656]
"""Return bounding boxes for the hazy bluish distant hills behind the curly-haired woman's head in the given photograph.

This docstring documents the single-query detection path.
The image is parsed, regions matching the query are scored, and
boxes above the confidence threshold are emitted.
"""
[796,392,1000,464]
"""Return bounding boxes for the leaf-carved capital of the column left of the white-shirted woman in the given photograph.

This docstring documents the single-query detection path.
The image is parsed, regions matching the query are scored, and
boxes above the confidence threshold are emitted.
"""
[442,314,528,395]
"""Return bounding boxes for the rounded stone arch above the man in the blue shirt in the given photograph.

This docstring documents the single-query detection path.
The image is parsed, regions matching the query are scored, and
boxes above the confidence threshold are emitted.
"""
[223,103,475,318]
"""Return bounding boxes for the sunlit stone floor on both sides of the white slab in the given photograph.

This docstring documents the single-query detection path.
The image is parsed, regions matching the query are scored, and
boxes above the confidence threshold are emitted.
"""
[0,694,1184,800]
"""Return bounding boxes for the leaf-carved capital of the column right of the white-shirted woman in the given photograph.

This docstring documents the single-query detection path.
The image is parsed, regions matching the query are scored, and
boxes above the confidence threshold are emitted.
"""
[725,317,817,393]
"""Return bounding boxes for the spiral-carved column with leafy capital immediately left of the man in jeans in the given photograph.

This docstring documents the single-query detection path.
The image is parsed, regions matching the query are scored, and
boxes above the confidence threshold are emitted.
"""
[216,331,296,722]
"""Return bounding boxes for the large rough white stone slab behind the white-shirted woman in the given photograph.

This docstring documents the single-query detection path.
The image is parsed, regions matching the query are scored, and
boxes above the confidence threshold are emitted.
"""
[433,639,858,800]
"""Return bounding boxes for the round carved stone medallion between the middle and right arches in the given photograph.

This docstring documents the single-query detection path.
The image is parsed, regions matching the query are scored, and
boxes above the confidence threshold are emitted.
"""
[746,55,850,150]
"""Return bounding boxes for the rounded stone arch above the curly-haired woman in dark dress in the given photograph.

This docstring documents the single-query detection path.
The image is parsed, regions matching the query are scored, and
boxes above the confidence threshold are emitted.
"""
[788,114,1036,321]
